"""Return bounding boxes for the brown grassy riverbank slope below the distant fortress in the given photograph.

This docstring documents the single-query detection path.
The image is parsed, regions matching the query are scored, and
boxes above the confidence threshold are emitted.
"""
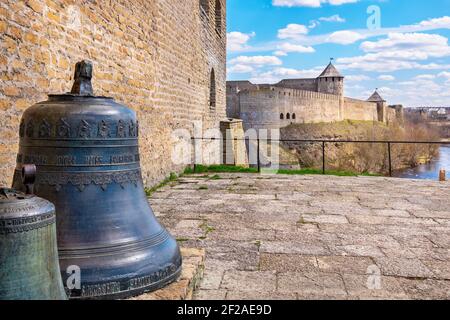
[281,121,439,174]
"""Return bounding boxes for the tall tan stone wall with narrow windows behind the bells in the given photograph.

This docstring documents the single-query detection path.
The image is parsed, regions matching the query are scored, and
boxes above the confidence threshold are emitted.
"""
[0,0,226,185]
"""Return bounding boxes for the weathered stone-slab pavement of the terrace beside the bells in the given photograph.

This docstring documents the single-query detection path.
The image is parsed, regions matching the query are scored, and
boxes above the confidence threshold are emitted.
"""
[150,174,450,300]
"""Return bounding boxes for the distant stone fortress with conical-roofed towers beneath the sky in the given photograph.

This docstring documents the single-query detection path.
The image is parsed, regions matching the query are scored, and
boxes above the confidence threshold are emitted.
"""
[227,72,403,129]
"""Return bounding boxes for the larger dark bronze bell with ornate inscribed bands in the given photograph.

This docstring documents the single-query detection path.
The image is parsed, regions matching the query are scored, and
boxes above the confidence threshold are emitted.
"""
[14,61,181,299]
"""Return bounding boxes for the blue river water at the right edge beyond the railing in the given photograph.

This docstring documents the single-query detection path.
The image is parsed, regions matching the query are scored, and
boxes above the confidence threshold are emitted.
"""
[394,145,450,180]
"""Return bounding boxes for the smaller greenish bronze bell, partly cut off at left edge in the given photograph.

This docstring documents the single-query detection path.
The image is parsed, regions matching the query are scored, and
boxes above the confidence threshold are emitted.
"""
[0,166,67,300]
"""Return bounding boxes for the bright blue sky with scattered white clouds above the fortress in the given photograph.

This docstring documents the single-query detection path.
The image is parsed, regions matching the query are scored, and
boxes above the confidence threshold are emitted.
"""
[227,0,450,107]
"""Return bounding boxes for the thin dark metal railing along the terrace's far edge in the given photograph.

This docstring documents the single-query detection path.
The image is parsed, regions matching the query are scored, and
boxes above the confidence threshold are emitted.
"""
[191,137,450,177]
